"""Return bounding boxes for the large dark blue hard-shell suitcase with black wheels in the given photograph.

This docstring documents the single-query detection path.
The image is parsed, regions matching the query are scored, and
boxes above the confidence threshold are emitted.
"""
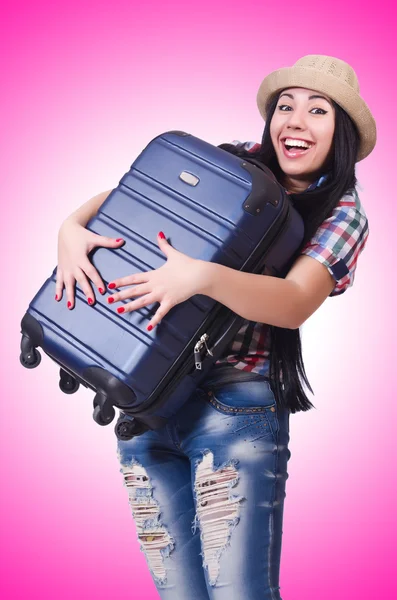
[20,131,304,439]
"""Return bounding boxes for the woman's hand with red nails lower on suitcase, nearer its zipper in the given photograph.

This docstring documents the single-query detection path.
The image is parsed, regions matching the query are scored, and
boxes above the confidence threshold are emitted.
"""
[108,231,211,331]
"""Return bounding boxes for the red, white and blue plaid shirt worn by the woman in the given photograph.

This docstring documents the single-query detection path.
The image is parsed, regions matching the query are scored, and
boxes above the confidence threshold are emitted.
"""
[214,140,369,379]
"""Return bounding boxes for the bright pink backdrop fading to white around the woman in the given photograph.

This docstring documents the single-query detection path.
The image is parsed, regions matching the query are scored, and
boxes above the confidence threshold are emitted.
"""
[0,0,397,600]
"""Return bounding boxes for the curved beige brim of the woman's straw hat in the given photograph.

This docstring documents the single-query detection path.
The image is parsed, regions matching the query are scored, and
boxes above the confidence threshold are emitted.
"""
[257,67,376,162]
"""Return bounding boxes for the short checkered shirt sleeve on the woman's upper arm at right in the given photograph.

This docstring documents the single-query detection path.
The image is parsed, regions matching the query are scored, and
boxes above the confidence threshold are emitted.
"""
[301,191,369,296]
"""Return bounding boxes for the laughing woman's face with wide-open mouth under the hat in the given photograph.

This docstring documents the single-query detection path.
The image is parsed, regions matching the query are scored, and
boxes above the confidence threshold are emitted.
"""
[270,87,335,193]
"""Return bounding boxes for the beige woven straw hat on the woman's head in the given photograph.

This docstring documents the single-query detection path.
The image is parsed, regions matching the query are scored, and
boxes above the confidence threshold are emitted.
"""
[257,54,376,162]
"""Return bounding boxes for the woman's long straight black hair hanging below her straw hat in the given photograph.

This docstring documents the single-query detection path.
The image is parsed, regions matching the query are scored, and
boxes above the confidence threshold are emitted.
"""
[220,92,360,413]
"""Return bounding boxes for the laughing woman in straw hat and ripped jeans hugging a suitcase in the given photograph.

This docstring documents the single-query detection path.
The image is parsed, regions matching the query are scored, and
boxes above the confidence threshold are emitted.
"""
[56,55,376,600]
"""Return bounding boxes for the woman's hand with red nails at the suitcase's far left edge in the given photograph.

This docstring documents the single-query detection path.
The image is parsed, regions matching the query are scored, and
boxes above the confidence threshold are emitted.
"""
[55,219,124,309]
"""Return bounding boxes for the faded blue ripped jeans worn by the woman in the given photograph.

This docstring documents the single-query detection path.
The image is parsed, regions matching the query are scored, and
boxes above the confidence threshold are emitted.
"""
[117,380,290,600]
